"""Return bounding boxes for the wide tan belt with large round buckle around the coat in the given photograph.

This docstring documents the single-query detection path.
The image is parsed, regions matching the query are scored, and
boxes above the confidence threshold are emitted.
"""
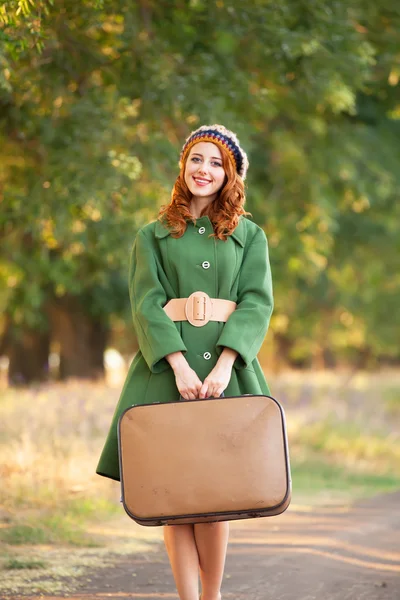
[164,291,236,327]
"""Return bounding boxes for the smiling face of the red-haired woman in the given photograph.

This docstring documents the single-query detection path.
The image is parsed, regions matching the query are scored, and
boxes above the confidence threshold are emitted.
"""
[184,142,225,200]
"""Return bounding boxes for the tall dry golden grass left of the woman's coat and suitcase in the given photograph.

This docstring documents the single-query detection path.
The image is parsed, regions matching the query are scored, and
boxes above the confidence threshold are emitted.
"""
[0,381,119,512]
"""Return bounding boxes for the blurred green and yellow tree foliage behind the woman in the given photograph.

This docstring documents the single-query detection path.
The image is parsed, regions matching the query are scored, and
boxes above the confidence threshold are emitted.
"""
[0,0,400,365]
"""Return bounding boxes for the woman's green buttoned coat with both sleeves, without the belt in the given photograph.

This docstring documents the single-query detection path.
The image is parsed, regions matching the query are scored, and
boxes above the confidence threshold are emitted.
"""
[96,216,273,480]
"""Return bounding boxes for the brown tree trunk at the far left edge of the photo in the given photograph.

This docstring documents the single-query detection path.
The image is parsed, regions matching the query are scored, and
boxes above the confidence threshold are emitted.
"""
[1,319,50,386]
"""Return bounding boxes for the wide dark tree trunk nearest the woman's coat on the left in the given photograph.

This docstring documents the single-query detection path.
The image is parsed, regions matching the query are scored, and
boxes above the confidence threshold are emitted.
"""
[49,296,109,379]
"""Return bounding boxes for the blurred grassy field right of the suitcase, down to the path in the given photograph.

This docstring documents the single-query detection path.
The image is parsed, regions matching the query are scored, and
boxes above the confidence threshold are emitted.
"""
[271,371,400,503]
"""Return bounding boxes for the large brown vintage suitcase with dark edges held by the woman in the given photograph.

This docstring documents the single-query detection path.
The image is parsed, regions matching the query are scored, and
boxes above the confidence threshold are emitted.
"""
[118,394,291,526]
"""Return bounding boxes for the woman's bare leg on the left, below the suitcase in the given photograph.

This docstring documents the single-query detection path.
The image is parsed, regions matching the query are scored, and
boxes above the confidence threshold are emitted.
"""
[164,525,199,600]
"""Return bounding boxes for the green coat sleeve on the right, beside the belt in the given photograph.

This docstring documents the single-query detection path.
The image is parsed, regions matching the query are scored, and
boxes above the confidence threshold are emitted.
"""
[217,229,274,369]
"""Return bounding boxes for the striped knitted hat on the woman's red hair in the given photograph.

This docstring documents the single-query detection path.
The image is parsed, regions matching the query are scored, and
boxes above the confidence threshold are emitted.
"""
[179,125,249,179]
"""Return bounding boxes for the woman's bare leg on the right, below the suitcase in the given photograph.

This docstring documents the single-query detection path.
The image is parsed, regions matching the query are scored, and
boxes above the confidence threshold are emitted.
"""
[194,521,229,600]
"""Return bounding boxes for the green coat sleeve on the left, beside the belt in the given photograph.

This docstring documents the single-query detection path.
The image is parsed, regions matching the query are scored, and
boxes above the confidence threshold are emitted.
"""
[129,231,187,373]
